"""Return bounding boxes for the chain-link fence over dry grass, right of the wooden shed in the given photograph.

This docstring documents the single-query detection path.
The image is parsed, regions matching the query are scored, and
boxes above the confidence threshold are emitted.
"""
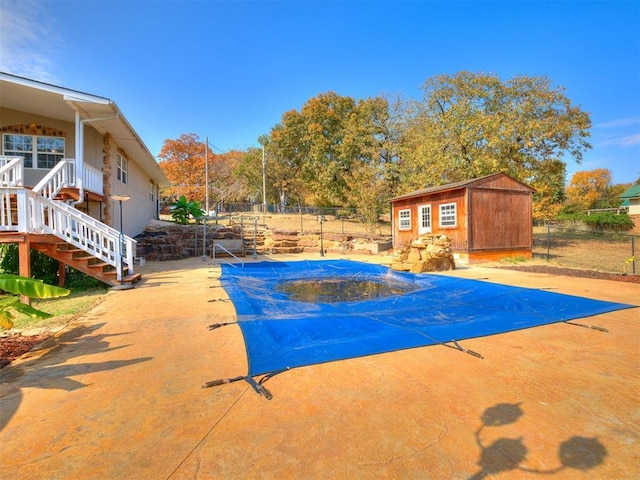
[533,225,640,275]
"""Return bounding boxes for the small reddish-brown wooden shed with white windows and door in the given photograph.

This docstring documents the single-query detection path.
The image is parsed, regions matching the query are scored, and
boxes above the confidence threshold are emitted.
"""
[391,173,534,263]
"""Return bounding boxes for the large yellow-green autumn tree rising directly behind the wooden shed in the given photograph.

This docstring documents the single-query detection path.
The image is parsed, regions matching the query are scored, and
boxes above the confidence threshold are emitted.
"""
[399,72,591,203]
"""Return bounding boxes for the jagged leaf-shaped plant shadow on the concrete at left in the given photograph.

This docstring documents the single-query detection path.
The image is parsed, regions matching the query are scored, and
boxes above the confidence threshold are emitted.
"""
[0,323,152,431]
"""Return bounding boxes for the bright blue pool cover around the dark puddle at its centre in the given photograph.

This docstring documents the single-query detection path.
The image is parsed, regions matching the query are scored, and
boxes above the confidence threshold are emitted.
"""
[220,260,633,376]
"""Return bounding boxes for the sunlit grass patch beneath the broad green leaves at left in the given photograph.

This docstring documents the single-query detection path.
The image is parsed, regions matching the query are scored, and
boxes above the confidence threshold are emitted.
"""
[0,287,109,331]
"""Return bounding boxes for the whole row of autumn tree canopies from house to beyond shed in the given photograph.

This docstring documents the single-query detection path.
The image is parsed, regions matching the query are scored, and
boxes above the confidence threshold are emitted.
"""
[160,71,608,219]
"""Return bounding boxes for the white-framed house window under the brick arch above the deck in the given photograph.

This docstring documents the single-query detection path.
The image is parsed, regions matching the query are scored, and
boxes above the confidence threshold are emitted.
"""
[2,133,64,169]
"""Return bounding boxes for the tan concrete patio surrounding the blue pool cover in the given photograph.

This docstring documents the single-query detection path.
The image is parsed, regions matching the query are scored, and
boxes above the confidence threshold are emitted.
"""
[0,256,640,480]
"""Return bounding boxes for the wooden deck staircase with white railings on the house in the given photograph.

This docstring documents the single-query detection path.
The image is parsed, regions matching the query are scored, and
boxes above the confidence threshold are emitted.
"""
[0,157,141,286]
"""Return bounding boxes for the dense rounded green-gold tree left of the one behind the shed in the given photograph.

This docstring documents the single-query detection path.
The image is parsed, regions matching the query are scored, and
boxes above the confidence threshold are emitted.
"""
[264,92,393,210]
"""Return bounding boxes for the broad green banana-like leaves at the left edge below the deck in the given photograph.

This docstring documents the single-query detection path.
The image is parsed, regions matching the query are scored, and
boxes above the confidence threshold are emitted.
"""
[0,273,70,330]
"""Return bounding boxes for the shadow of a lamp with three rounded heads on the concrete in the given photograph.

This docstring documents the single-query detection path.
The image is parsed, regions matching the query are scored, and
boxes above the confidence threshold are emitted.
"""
[469,403,607,480]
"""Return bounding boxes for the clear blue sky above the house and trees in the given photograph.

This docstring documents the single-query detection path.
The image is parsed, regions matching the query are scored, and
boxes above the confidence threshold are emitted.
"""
[0,0,640,183]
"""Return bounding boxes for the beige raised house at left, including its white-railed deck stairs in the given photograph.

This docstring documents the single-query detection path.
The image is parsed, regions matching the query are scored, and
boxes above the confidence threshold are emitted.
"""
[0,72,169,284]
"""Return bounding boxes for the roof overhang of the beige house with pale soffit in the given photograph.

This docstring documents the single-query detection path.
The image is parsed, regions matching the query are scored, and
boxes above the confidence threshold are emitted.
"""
[0,72,170,187]
